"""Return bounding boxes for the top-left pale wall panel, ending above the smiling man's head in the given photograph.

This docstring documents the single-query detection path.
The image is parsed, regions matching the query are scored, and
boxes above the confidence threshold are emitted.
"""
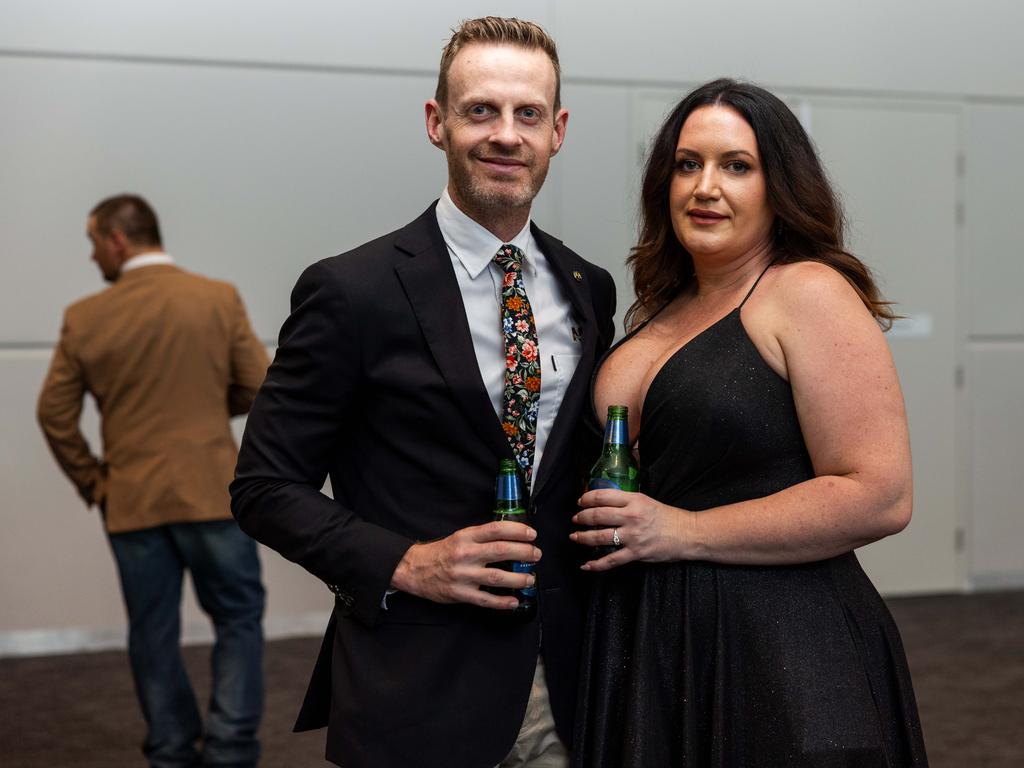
[0,0,550,73]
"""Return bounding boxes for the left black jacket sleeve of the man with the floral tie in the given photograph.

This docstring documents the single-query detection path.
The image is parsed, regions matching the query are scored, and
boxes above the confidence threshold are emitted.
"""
[230,262,413,625]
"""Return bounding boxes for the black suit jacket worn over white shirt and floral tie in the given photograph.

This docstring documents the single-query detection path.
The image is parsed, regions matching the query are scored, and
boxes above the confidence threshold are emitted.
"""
[231,206,614,768]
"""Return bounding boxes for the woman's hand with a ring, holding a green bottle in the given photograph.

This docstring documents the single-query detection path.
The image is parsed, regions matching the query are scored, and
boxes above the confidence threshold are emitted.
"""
[569,488,689,570]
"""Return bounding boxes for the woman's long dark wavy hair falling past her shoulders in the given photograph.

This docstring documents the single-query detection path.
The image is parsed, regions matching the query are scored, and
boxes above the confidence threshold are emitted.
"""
[626,79,896,329]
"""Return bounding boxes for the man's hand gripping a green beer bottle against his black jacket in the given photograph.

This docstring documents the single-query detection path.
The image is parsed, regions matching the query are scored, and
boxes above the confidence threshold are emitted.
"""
[391,522,541,610]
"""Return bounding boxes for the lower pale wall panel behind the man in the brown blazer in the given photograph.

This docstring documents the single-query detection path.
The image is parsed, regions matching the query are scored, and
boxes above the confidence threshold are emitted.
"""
[0,358,333,654]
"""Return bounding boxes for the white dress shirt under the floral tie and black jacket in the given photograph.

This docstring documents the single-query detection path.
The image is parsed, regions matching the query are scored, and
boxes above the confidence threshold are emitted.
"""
[437,187,583,487]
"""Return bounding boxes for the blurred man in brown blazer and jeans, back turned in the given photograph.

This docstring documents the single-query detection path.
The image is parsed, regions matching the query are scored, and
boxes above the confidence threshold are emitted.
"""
[39,195,268,768]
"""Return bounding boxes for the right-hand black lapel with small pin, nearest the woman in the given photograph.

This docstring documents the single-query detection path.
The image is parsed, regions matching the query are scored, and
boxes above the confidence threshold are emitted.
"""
[532,225,598,499]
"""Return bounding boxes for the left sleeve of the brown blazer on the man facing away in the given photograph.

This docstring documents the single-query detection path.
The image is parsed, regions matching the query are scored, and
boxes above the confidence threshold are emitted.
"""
[36,316,106,512]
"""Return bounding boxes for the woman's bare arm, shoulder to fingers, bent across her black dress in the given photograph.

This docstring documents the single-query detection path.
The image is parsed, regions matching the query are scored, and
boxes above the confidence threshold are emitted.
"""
[572,262,911,570]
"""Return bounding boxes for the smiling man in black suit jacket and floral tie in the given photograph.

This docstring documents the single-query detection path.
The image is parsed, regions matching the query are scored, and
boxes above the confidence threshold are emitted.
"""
[231,17,614,768]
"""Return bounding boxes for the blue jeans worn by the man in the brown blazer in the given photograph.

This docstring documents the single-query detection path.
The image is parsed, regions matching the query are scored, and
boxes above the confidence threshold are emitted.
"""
[110,520,263,768]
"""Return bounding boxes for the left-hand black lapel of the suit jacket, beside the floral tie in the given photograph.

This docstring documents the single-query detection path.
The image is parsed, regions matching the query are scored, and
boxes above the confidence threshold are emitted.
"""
[395,206,512,466]
